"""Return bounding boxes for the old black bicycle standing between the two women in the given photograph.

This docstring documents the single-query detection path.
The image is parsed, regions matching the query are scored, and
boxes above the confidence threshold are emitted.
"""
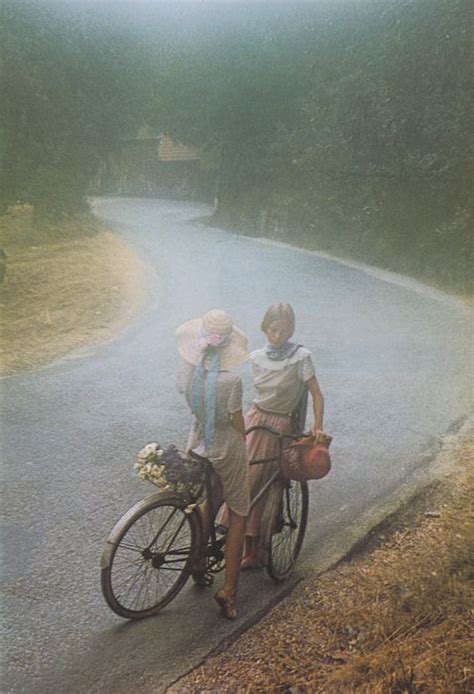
[101,426,308,619]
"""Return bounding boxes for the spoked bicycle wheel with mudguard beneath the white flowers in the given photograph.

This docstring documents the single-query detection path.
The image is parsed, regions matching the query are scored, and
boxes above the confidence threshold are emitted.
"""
[101,494,200,619]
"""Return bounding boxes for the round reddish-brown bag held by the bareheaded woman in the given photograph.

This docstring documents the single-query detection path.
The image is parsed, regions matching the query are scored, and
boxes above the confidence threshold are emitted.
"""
[280,434,332,482]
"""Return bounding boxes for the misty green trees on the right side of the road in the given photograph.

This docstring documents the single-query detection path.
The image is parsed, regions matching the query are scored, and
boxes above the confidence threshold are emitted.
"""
[158,0,472,289]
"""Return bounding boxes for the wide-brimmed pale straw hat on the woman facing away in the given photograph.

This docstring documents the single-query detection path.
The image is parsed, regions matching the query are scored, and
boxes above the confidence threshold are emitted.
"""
[176,309,248,369]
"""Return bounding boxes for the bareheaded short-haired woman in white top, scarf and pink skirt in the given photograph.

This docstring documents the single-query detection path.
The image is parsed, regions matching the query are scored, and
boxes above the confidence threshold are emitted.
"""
[218,303,324,569]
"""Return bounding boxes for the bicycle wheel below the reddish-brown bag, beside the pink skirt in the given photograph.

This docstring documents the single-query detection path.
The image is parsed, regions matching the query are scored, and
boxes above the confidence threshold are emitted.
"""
[266,480,308,583]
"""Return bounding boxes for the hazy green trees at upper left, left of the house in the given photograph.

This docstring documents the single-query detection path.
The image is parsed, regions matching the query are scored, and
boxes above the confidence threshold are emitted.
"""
[0,0,152,221]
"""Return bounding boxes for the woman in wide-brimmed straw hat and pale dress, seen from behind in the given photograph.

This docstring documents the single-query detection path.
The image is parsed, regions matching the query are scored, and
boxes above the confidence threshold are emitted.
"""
[176,309,250,619]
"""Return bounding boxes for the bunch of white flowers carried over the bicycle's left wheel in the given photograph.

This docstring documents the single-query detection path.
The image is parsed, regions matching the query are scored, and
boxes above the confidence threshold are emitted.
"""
[133,442,205,501]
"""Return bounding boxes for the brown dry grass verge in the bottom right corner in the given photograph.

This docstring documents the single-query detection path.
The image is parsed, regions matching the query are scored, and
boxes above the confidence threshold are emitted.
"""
[168,444,474,694]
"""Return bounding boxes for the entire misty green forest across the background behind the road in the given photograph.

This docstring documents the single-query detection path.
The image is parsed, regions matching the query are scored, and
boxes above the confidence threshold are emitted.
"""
[0,0,473,291]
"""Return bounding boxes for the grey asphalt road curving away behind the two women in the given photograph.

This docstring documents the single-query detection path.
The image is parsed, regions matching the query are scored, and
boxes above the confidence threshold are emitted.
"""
[1,199,472,693]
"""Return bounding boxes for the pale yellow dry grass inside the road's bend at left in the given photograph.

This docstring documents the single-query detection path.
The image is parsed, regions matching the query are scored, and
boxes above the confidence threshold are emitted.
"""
[0,208,147,375]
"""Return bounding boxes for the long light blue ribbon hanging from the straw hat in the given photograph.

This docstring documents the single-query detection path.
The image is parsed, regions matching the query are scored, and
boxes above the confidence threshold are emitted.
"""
[191,333,230,450]
